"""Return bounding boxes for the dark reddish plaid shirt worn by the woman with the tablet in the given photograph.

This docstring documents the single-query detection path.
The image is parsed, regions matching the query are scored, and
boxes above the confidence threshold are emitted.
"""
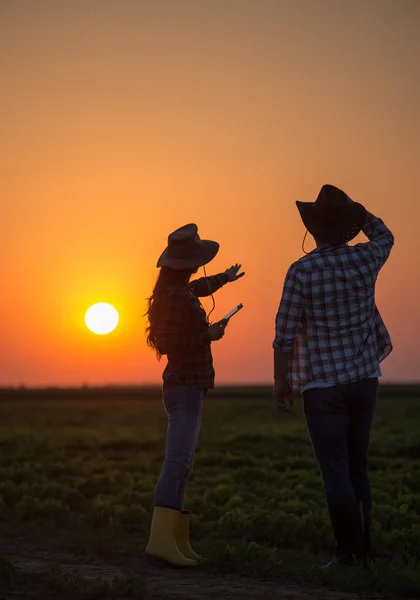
[157,273,228,390]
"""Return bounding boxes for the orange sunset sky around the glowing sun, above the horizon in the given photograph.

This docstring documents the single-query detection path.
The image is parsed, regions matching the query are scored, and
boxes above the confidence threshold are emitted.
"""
[0,0,420,385]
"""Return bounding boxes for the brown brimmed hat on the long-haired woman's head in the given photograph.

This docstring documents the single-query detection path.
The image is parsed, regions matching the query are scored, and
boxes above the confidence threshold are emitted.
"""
[156,223,219,269]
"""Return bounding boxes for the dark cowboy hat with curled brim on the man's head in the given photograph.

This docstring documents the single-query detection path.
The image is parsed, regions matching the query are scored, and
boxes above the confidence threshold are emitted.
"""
[296,185,366,246]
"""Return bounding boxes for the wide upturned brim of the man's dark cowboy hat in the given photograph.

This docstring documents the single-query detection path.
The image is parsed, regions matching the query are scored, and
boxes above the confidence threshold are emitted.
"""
[296,200,366,246]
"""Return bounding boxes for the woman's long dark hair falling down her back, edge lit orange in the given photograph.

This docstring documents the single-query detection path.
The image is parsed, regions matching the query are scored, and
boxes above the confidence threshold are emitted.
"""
[144,267,197,360]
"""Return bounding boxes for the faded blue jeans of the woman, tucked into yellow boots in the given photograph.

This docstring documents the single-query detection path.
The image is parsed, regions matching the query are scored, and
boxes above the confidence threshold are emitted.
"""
[155,385,205,509]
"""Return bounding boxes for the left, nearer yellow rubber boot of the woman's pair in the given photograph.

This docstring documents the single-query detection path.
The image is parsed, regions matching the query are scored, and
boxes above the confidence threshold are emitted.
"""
[146,506,197,567]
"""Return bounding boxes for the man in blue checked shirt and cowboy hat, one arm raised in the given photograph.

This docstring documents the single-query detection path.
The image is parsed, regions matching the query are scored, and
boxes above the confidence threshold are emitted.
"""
[273,185,394,570]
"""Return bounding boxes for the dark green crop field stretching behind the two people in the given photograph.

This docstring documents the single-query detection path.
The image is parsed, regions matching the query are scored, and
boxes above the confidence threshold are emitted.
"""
[0,389,420,598]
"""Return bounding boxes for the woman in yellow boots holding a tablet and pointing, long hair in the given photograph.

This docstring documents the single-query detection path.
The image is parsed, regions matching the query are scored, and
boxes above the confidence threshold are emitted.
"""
[146,223,244,566]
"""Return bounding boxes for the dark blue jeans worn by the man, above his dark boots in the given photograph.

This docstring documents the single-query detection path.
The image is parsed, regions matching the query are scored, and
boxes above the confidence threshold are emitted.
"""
[303,379,378,507]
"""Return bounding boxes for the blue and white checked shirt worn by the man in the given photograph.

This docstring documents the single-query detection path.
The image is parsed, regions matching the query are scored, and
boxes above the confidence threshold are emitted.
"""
[273,218,394,390]
